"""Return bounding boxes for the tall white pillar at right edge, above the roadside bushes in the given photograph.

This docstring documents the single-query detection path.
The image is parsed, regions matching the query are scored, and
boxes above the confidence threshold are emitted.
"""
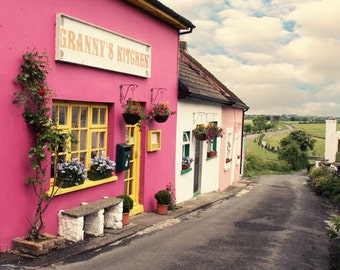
[325,119,340,163]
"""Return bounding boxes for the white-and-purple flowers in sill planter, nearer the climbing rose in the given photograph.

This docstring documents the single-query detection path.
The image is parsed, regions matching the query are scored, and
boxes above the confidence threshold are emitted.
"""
[56,158,86,188]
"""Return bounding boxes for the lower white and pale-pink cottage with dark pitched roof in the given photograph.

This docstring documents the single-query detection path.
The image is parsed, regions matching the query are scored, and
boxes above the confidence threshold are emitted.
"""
[176,42,248,203]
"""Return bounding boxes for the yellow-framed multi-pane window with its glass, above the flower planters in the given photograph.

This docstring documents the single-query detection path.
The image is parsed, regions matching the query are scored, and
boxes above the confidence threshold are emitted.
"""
[51,102,116,194]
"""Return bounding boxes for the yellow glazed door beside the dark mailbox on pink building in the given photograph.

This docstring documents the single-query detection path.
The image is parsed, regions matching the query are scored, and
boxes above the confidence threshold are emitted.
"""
[124,124,144,215]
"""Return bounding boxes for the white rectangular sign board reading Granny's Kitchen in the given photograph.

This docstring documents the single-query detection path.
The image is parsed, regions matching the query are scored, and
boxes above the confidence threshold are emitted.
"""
[55,13,151,78]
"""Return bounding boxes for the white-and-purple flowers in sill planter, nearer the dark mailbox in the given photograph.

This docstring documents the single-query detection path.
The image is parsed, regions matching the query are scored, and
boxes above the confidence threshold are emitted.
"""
[87,156,116,181]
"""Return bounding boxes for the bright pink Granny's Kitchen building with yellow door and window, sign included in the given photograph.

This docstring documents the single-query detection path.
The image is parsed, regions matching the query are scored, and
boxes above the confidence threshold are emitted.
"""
[0,0,194,252]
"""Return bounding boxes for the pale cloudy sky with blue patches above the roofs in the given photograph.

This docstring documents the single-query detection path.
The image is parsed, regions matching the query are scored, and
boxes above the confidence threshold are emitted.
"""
[160,0,340,117]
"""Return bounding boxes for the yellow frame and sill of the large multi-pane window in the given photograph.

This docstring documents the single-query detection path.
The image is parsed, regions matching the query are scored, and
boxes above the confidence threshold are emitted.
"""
[47,101,118,195]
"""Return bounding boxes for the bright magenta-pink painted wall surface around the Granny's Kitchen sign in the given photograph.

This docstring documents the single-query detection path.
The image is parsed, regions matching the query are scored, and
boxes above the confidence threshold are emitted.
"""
[0,0,178,251]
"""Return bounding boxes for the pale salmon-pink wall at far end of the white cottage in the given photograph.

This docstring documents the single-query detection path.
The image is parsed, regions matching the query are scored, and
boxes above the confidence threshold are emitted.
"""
[219,107,243,190]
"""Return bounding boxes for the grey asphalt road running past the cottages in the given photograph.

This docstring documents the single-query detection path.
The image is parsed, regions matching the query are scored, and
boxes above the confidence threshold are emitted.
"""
[45,173,331,270]
